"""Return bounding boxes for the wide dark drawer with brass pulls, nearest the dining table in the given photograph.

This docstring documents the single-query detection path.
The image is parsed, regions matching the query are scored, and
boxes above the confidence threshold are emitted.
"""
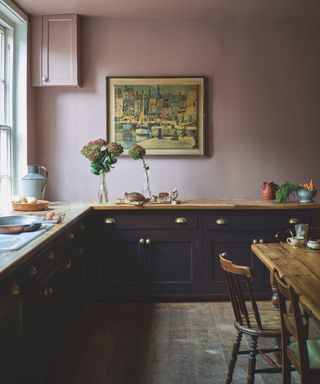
[204,212,311,231]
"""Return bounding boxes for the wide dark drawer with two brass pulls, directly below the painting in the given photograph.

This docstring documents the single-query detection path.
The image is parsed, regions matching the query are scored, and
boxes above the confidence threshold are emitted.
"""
[95,211,198,230]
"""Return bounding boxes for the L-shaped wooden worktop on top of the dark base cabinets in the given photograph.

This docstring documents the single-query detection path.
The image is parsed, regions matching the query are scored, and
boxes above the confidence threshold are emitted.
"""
[0,200,320,278]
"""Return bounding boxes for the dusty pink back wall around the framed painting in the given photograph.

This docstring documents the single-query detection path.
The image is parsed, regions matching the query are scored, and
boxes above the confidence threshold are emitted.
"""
[29,18,320,200]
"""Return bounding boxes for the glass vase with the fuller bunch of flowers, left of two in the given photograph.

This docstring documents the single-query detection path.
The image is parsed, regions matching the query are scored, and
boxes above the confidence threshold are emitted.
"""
[81,139,123,203]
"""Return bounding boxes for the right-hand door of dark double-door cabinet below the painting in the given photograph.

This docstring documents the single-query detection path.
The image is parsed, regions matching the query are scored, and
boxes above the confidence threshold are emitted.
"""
[144,231,199,296]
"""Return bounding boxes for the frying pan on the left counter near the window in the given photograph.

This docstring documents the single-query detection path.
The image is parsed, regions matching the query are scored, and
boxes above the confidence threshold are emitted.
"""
[0,216,43,234]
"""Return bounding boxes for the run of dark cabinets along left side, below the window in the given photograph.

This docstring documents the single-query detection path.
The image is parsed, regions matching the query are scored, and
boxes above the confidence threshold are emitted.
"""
[0,218,89,384]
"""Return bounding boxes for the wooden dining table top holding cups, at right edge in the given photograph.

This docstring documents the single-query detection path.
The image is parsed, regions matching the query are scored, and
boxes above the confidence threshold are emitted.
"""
[251,244,320,322]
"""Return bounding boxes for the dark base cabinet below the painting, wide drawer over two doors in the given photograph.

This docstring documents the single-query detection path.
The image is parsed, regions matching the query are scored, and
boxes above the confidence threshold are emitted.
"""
[90,212,199,299]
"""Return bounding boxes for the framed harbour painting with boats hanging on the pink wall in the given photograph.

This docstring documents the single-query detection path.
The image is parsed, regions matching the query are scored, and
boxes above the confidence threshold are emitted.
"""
[107,77,205,155]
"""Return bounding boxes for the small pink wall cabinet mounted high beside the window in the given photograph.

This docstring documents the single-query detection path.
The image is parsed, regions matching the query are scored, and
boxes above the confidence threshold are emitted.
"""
[31,15,80,87]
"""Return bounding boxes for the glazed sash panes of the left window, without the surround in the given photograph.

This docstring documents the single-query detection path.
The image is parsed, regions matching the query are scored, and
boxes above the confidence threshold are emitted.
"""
[0,19,13,206]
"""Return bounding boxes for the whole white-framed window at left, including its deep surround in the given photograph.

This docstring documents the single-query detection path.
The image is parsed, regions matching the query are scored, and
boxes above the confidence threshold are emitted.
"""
[0,0,28,210]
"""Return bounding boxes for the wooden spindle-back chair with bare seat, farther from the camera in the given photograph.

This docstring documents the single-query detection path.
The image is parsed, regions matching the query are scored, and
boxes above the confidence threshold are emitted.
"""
[219,253,281,384]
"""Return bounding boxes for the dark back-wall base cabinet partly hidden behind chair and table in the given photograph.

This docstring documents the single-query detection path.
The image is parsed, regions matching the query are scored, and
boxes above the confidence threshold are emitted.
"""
[202,210,313,299]
